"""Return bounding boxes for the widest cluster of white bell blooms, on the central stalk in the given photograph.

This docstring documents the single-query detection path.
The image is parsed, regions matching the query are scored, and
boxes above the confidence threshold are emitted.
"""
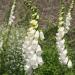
[22,20,44,71]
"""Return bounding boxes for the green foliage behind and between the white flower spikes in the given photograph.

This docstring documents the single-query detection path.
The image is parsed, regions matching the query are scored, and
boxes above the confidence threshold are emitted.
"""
[0,0,75,75]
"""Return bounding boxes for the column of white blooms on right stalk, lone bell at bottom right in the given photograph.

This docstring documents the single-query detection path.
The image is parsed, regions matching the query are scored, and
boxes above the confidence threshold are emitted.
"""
[56,26,72,68]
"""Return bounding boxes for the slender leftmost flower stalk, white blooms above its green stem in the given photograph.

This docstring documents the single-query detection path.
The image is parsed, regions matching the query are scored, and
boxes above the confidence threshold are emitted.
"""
[3,0,16,45]
